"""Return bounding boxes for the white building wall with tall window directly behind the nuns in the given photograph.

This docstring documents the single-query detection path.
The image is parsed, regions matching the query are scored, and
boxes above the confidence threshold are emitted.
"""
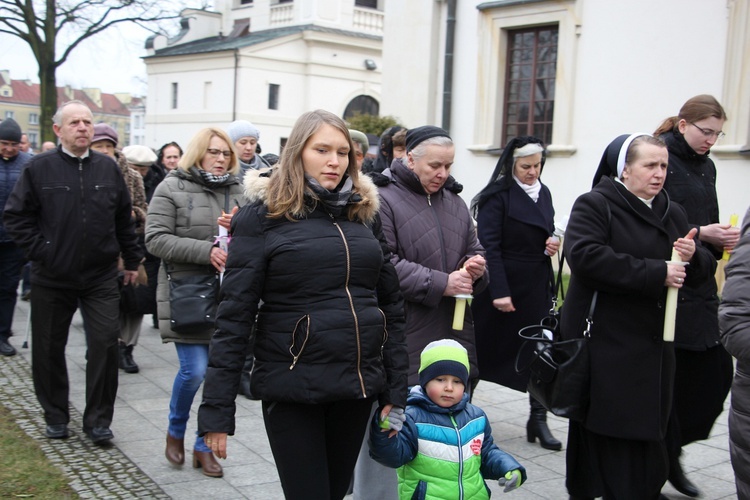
[380,0,750,225]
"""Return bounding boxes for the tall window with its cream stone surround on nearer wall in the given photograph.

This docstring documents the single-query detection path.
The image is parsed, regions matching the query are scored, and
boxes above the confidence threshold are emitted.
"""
[476,0,580,158]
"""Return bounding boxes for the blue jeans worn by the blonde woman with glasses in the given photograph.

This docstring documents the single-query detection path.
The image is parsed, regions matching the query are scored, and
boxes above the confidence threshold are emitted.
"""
[167,342,211,451]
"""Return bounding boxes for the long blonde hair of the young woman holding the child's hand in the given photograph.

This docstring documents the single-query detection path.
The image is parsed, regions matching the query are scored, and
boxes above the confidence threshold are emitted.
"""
[267,109,368,220]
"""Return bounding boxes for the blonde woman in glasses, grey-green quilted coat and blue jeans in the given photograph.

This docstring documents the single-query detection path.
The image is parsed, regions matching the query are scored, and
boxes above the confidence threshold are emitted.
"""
[146,128,245,477]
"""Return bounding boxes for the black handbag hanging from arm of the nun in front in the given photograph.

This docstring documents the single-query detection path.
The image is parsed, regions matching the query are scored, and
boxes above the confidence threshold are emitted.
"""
[516,292,598,422]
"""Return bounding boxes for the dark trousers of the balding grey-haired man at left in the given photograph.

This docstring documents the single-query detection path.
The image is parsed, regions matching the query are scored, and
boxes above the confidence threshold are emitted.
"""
[31,278,120,428]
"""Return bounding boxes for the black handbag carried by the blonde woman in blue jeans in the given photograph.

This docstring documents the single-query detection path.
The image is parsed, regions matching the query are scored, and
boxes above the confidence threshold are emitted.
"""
[167,271,219,334]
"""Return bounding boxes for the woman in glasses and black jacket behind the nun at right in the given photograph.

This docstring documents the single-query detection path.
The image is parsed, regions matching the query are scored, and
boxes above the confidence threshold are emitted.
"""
[654,94,739,497]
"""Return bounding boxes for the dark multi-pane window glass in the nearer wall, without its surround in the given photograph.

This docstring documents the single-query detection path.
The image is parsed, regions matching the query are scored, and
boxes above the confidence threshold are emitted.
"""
[501,26,557,144]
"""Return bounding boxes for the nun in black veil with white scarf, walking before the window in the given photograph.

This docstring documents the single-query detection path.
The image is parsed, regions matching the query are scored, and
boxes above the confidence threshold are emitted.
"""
[471,136,562,450]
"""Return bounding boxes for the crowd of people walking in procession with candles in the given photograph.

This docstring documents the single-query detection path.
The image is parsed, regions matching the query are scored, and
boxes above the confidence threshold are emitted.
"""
[0,95,750,499]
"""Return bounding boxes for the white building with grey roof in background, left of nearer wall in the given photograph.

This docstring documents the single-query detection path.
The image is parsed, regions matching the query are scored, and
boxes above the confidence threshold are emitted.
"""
[144,0,384,154]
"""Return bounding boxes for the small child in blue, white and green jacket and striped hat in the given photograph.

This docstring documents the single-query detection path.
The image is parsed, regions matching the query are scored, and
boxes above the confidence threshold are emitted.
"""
[370,339,526,500]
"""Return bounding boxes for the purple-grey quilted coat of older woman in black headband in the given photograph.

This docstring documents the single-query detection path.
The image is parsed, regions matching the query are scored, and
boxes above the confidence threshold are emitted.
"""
[374,160,488,385]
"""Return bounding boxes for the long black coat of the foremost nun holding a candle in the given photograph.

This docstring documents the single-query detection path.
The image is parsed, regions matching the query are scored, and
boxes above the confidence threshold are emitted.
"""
[561,178,713,441]
